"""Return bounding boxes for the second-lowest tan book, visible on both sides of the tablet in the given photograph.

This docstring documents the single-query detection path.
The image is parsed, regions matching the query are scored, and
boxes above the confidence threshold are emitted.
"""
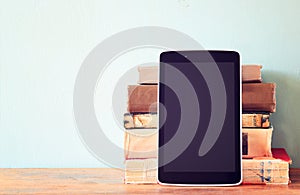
[124,127,273,159]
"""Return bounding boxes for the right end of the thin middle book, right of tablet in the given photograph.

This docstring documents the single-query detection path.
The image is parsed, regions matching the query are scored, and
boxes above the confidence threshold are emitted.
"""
[242,113,271,128]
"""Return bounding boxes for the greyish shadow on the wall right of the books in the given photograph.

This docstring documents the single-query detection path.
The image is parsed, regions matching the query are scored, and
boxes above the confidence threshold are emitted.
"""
[262,70,300,168]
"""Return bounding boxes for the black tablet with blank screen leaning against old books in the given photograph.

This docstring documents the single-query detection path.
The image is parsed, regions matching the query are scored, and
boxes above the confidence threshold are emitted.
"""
[158,51,242,186]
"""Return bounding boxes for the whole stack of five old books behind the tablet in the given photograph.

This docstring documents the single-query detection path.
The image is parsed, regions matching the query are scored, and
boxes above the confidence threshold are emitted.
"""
[124,65,291,184]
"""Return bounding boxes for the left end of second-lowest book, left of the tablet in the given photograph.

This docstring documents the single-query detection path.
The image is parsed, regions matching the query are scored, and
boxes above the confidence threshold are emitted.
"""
[124,129,158,159]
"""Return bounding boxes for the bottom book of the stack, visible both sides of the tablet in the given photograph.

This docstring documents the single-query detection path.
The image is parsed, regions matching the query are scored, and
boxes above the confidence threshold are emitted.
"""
[124,148,292,185]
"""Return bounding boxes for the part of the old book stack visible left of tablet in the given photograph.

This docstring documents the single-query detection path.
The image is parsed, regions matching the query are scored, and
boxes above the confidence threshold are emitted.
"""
[124,67,158,184]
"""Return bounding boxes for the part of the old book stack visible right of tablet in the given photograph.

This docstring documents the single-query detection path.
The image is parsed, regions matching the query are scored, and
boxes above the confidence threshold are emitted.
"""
[242,65,291,184]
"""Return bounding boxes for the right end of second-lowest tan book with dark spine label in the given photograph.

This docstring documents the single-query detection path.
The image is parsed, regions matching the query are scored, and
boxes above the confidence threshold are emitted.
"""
[242,127,273,158]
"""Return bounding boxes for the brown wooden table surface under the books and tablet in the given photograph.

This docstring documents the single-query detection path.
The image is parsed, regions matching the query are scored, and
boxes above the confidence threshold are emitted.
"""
[0,168,300,195]
